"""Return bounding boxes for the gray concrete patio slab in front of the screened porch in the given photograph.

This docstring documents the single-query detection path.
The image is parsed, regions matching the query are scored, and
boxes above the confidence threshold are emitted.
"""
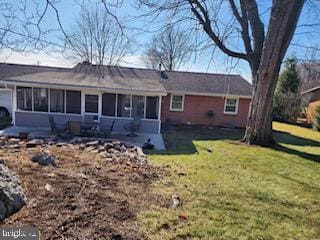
[0,127,165,150]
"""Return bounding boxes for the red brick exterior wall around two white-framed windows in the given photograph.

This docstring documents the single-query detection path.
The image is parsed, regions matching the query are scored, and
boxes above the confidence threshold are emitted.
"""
[161,94,251,127]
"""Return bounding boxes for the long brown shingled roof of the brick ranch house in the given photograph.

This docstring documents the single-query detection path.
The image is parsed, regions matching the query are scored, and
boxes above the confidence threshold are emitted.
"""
[0,63,251,97]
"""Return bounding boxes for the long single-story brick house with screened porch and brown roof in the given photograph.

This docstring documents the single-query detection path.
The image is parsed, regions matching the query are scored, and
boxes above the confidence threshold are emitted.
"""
[0,63,251,133]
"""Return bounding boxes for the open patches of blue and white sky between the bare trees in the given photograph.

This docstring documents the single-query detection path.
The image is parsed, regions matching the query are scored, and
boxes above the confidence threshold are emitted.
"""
[0,0,320,81]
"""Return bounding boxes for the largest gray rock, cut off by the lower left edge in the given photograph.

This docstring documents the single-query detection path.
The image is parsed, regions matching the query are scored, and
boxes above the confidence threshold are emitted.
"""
[0,163,27,221]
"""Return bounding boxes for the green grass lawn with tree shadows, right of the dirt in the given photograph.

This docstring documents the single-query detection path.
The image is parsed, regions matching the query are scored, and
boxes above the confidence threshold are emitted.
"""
[139,123,320,240]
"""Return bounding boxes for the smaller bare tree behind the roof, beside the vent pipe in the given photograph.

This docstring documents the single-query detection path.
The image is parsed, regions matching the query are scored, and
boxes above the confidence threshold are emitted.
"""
[143,26,193,71]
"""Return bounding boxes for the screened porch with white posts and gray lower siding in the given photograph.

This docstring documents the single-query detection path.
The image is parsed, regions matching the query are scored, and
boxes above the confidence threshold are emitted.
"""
[13,86,161,133]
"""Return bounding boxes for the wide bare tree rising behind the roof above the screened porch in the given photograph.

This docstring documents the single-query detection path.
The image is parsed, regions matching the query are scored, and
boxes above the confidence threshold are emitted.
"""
[66,7,130,65]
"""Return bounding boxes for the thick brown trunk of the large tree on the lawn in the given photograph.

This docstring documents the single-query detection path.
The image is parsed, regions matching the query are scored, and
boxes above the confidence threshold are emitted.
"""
[243,0,304,146]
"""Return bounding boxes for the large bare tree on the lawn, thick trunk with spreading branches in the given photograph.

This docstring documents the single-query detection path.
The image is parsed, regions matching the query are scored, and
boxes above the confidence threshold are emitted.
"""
[139,0,312,145]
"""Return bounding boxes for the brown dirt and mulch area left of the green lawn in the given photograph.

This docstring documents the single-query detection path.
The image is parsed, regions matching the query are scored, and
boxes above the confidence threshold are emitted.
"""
[0,145,160,239]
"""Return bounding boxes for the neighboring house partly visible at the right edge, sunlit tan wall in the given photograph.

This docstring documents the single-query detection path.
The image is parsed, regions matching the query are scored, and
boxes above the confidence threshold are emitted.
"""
[302,86,320,124]
